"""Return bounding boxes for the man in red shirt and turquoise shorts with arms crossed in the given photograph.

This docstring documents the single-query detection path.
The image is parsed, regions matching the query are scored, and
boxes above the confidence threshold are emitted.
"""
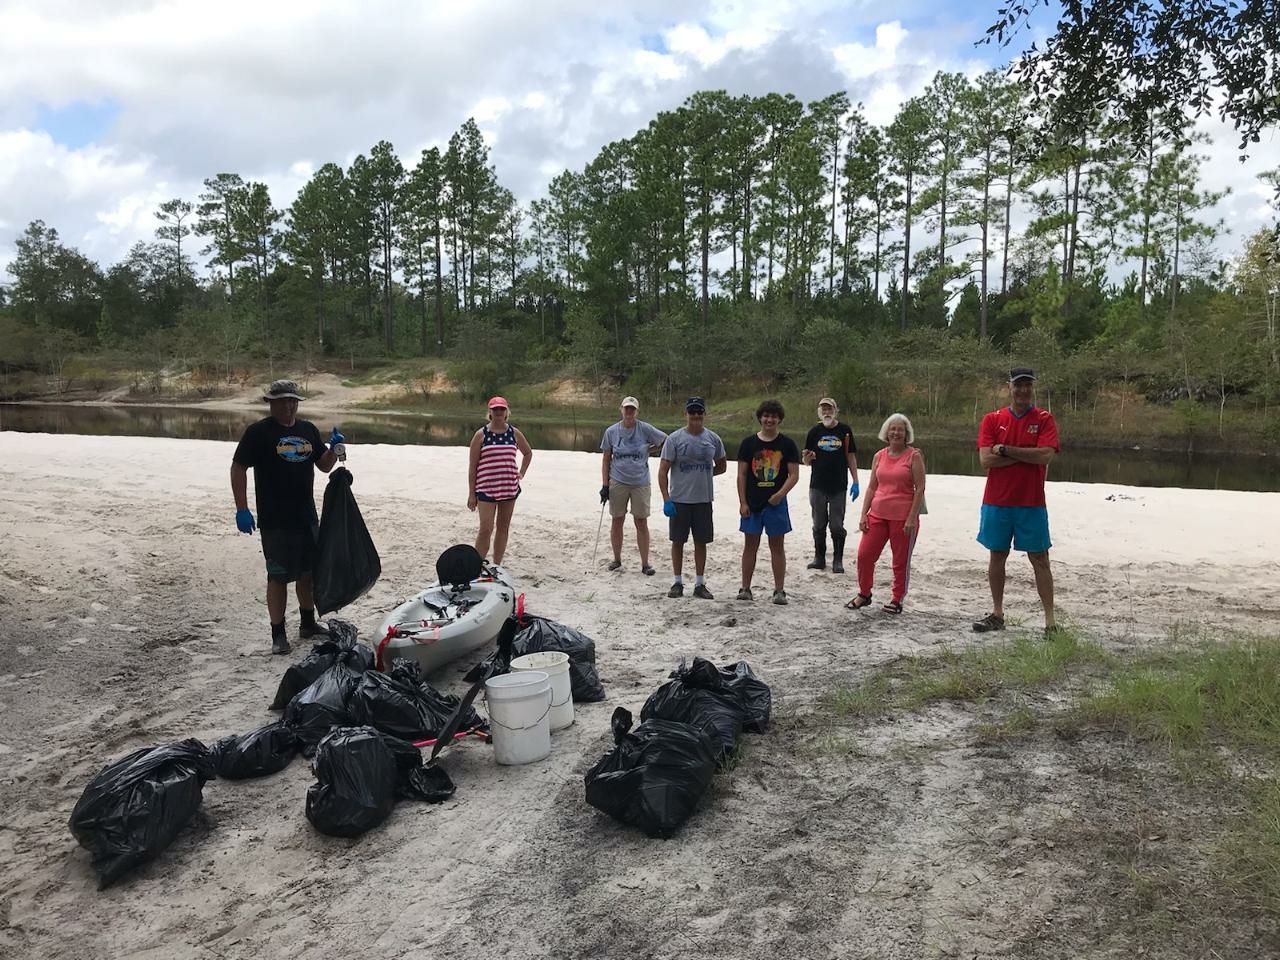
[973,366,1059,637]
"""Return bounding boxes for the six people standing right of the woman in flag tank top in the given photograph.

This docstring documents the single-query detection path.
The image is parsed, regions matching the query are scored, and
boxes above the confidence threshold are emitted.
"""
[600,367,1059,635]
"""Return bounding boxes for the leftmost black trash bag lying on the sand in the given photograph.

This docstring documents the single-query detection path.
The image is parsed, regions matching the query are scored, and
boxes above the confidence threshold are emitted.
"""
[68,740,214,890]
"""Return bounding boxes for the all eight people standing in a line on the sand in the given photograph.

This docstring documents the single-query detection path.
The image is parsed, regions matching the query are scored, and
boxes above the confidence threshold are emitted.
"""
[230,367,1059,653]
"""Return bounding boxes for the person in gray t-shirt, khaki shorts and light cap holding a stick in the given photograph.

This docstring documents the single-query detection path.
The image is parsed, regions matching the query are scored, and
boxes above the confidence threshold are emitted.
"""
[600,397,667,576]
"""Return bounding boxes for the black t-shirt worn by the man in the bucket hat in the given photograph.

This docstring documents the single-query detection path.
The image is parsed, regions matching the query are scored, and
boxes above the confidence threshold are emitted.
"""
[232,417,328,530]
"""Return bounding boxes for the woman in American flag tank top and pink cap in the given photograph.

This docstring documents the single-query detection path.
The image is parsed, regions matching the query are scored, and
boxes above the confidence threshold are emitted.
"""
[467,397,534,564]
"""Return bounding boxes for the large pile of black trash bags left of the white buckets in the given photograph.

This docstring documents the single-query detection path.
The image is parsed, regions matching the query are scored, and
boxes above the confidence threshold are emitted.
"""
[69,620,476,888]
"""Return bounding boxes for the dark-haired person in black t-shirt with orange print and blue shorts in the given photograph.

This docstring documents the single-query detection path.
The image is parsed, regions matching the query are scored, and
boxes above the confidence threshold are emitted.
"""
[737,399,800,603]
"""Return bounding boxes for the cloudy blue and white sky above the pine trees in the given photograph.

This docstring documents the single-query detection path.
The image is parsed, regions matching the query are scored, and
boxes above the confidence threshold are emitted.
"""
[0,0,1280,285]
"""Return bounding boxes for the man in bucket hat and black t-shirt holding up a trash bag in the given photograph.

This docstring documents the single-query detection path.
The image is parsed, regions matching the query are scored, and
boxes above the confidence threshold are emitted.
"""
[232,380,347,653]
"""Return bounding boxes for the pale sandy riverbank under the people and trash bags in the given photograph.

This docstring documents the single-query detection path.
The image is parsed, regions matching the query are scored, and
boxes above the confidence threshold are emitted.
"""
[0,433,1280,960]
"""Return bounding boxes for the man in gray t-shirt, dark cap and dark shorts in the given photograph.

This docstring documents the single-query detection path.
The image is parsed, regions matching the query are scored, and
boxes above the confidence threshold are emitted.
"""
[658,397,728,600]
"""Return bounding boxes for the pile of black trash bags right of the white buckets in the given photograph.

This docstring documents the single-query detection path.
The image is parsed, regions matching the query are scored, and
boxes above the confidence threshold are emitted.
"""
[585,657,772,837]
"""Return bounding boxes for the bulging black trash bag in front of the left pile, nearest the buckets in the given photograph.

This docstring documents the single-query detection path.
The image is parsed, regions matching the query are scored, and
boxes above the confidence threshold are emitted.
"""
[306,727,453,837]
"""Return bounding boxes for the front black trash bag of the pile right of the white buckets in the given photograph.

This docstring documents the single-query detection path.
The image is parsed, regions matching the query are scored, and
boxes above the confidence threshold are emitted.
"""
[584,707,718,837]
